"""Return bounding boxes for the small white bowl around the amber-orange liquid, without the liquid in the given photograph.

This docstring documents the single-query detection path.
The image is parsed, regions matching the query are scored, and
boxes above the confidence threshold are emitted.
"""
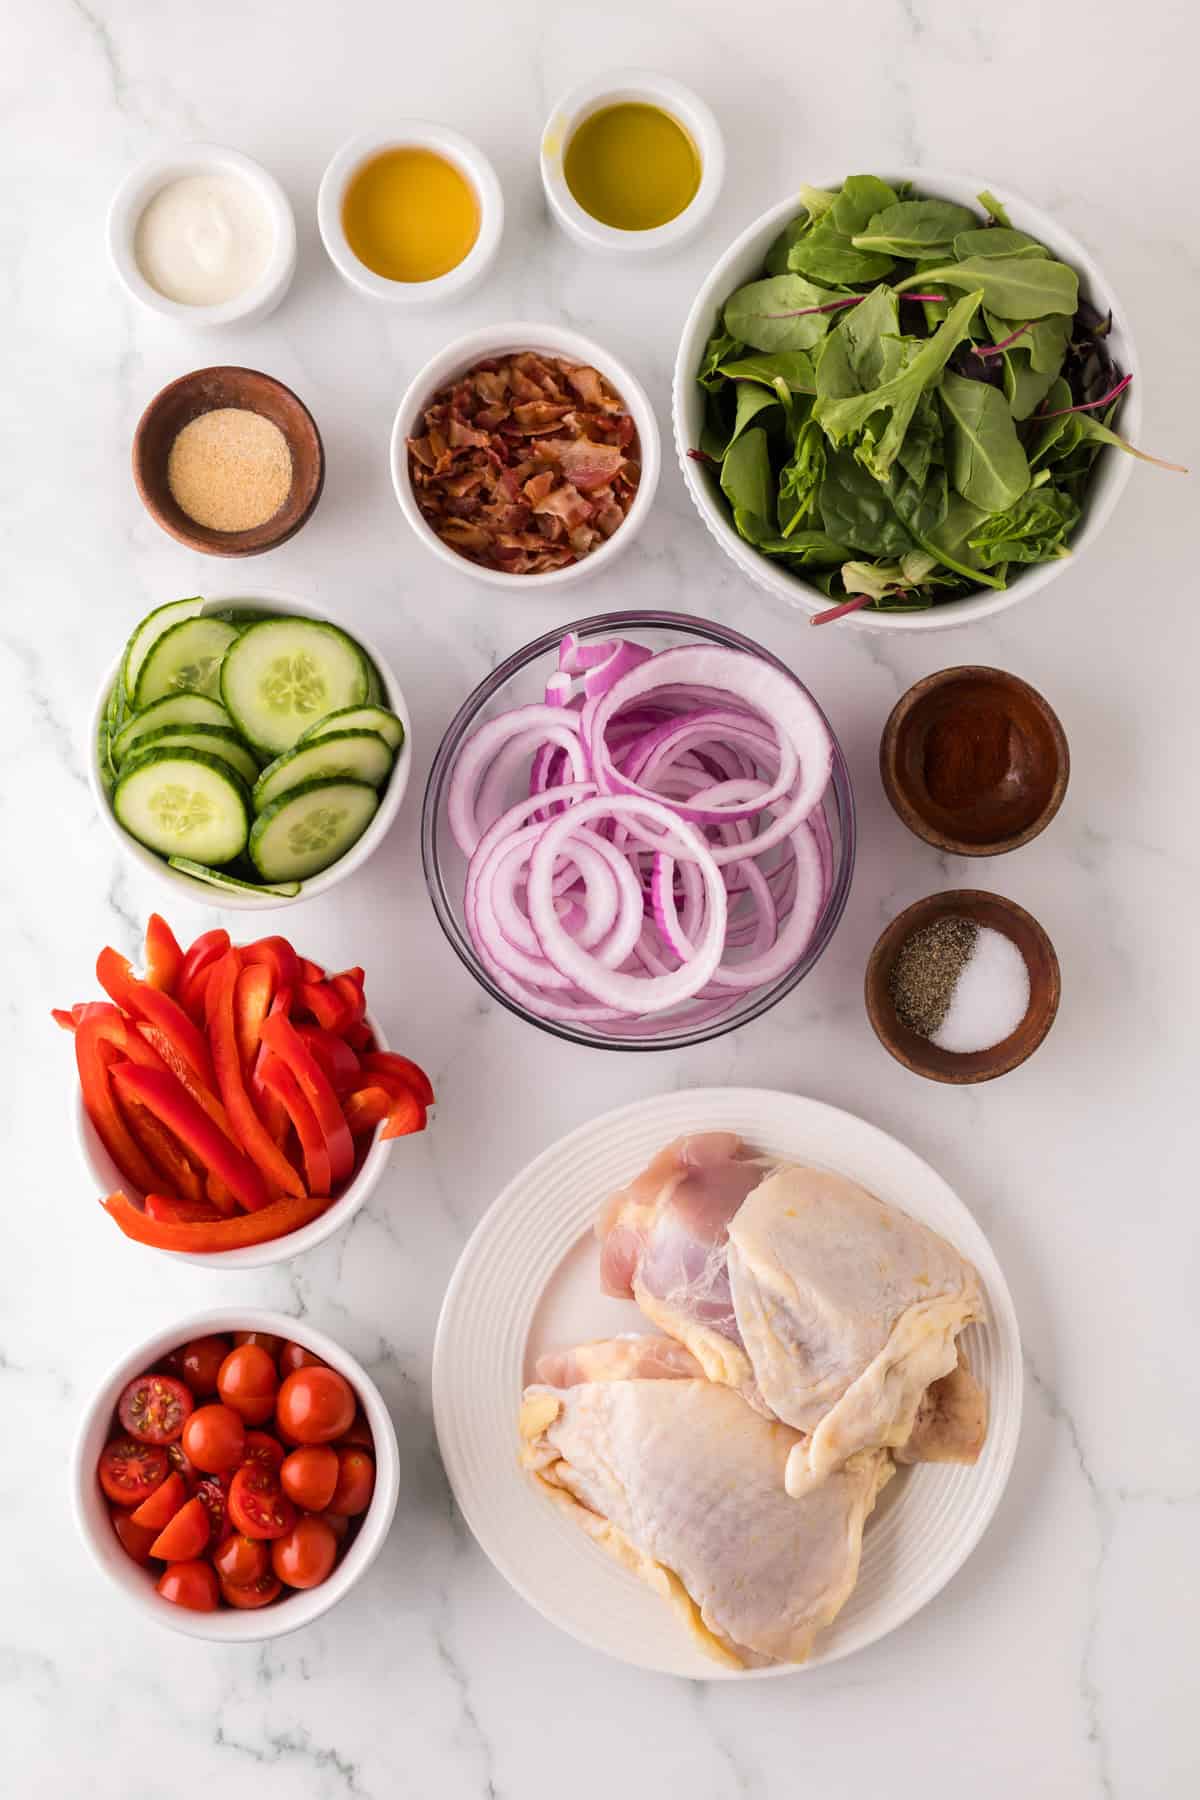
[317,119,504,306]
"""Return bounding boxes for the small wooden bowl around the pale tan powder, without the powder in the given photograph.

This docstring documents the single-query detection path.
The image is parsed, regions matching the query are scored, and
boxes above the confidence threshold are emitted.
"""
[133,367,326,556]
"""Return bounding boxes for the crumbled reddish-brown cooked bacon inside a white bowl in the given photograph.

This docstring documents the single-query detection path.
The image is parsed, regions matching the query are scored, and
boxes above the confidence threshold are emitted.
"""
[408,351,640,574]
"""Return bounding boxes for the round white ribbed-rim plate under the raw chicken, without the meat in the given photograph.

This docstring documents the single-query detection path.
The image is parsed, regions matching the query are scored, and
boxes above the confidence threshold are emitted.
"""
[434,1087,1022,1681]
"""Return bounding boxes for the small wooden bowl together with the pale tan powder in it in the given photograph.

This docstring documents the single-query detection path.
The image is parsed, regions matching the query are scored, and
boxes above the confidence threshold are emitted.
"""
[133,367,326,556]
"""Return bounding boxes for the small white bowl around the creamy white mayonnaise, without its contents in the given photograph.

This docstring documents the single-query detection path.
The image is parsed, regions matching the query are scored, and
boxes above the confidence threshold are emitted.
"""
[108,144,295,326]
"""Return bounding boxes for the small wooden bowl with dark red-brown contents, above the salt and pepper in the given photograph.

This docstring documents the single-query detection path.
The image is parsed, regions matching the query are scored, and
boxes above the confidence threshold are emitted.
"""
[880,668,1070,857]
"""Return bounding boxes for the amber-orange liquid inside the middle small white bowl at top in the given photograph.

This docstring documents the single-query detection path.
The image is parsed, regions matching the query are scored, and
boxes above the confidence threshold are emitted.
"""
[342,148,479,281]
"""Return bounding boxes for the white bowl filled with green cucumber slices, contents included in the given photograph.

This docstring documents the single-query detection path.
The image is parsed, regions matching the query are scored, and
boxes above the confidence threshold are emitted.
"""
[88,594,412,911]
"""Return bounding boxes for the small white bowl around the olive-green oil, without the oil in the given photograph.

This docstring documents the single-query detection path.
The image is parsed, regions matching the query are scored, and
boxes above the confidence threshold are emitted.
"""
[540,68,725,256]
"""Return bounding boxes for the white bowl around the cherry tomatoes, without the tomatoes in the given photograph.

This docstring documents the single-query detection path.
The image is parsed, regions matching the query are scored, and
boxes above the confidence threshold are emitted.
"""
[70,1307,399,1643]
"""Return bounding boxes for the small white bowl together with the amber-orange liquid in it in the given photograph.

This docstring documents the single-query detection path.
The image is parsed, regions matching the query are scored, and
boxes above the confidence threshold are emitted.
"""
[317,119,504,306]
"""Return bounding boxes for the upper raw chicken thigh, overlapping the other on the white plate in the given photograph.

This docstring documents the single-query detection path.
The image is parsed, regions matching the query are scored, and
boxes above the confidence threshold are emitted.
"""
[597,1132,986,1496]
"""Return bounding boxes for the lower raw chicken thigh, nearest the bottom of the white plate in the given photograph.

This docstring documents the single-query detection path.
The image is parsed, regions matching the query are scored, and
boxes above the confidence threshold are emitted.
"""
[520,1339,892,1669]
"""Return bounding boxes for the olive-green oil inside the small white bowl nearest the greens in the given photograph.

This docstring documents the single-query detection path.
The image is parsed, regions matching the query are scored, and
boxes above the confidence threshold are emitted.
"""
[563,101,700,230]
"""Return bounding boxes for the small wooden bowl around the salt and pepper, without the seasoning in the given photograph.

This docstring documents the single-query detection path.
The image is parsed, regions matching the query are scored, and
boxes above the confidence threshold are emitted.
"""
[865,887,1061,1087]
